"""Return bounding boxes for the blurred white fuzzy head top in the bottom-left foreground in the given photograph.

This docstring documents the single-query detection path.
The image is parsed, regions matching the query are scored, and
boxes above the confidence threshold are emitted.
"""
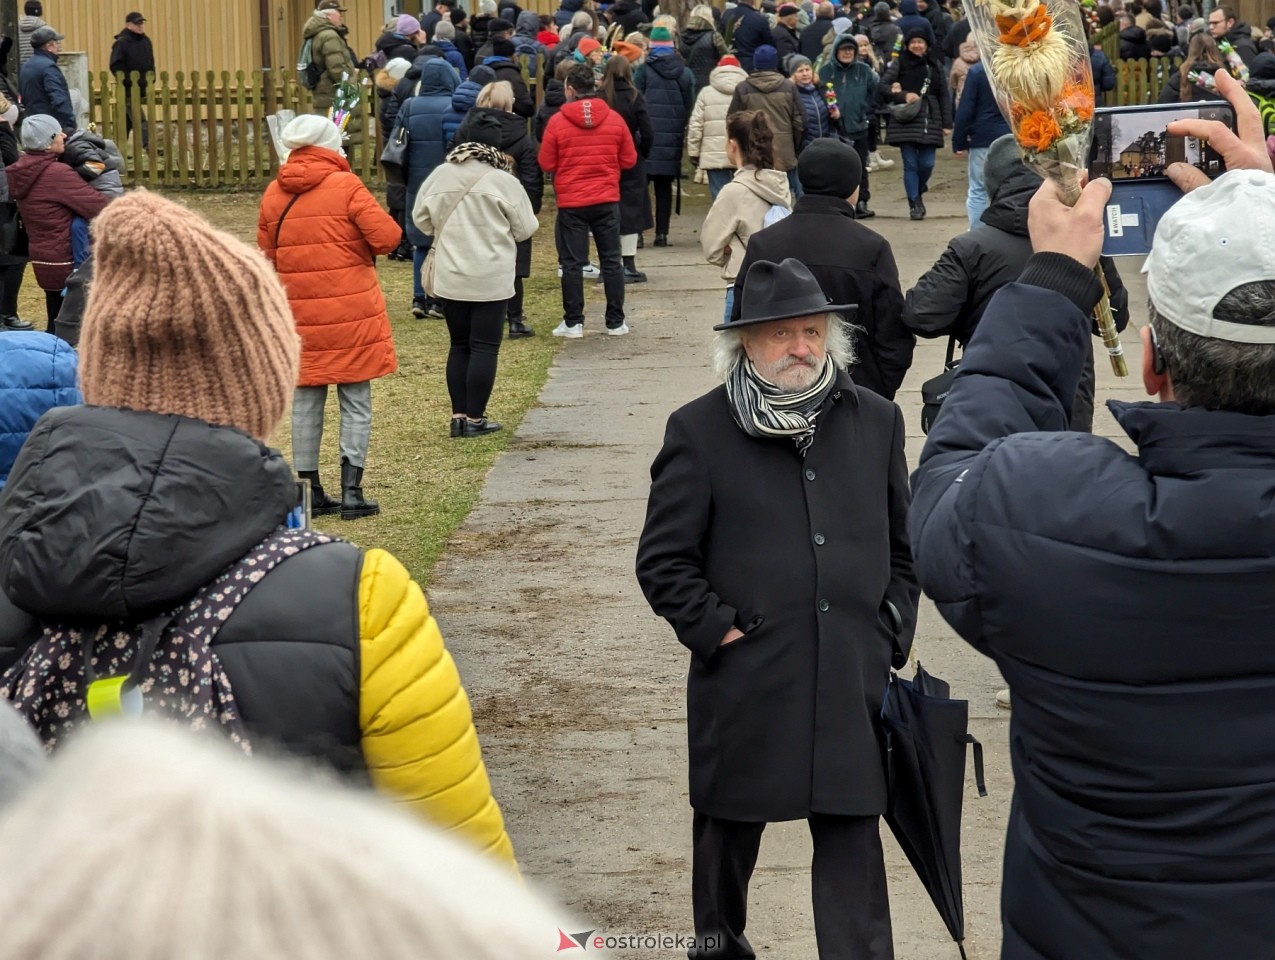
[0,720,581,960]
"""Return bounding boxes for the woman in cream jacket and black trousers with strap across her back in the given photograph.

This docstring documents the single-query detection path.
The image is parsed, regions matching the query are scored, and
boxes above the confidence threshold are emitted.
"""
[412,115,539,437]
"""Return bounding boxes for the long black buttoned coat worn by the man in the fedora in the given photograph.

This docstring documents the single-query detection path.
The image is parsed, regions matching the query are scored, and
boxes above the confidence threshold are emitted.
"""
[638,374,917,822]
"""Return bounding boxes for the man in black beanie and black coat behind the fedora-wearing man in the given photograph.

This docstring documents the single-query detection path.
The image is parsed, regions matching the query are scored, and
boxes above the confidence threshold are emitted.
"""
[732,136,917,400]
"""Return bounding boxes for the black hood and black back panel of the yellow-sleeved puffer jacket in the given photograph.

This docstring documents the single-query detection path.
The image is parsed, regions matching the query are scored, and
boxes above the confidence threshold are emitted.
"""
[0,407,365,770]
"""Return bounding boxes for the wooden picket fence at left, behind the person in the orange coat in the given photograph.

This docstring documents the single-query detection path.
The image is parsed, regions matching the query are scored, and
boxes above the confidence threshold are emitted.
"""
[89,70,380,189]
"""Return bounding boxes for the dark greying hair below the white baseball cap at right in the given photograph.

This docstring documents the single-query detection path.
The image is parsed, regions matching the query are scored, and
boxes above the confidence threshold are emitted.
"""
[1146,280,1275,417]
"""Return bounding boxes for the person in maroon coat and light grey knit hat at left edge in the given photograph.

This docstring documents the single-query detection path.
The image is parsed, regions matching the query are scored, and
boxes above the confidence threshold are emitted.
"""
[5,113,111,333]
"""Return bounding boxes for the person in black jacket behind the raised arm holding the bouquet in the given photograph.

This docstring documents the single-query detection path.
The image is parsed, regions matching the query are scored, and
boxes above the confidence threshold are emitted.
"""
[903,134,1128,432]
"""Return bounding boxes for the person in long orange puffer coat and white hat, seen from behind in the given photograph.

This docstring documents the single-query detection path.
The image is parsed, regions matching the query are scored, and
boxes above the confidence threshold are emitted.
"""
[256,115,403,520]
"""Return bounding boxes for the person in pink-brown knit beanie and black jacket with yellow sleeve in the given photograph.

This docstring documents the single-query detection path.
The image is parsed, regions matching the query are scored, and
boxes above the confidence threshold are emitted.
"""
[0,190,513,866]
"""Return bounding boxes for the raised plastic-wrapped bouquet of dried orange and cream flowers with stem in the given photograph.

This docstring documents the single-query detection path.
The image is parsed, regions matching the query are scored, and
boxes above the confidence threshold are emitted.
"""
[966,0,1128,376]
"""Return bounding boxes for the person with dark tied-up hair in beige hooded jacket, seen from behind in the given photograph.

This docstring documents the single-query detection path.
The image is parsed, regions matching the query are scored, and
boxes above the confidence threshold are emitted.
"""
[700,110,792,321]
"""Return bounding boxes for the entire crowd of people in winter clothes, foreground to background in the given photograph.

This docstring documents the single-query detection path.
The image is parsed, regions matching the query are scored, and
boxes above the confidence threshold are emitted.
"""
[0,0,1275,960]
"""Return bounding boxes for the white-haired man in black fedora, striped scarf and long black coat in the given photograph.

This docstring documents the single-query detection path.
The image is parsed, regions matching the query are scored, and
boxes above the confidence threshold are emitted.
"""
[638,259,917,960]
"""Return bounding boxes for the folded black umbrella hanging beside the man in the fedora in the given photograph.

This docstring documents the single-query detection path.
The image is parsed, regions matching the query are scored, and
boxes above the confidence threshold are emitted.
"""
[881,663,987,957]
